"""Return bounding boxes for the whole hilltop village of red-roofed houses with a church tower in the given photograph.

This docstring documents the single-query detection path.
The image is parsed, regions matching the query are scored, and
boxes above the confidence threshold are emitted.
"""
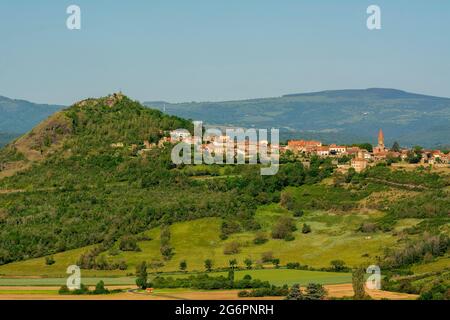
[111,129,450,172]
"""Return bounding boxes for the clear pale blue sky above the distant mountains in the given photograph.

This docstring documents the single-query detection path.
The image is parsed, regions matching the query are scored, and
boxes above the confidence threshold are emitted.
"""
[0,0,450,104]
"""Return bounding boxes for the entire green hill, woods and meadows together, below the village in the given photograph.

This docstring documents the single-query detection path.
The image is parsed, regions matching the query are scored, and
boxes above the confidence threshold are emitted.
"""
[0,94,450,300]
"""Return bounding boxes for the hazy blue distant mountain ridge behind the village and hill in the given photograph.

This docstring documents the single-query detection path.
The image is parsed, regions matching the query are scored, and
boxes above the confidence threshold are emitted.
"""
[0,88,450,148]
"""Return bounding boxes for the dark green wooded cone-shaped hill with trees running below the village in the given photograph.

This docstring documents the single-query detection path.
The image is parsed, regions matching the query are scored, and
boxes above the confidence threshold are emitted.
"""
[0,95,331,264]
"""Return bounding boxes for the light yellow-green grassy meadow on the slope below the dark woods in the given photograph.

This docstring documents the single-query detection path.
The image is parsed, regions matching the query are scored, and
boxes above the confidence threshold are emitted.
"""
[0,204,397,277]
